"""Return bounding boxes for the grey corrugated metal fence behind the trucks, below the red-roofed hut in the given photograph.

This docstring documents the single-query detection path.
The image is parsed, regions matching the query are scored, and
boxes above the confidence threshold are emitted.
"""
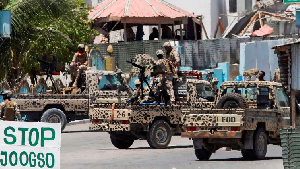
[94,36,289,72]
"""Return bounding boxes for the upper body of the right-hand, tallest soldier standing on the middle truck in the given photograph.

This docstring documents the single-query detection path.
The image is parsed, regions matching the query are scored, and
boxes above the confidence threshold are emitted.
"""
[162,42,181,78]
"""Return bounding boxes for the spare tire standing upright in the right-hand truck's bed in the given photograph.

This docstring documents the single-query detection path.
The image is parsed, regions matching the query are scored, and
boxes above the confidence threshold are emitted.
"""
[216,93,249,109]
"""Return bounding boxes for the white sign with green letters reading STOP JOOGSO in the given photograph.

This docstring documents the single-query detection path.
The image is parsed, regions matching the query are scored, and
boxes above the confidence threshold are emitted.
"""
[0,121,61,169]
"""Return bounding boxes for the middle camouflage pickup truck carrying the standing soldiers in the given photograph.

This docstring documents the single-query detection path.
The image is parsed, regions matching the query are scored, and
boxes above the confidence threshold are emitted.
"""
[90,74,215,149]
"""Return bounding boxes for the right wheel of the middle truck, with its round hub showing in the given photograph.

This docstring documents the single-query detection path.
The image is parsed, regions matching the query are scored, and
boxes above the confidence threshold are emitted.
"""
[147,120,172,149]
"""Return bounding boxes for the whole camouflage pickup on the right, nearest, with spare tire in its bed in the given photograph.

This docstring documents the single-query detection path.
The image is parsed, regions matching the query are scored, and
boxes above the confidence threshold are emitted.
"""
[181,81,292,160]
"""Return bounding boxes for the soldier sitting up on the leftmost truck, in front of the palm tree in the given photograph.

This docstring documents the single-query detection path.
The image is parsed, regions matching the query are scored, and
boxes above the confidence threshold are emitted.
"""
[70,44,88,87]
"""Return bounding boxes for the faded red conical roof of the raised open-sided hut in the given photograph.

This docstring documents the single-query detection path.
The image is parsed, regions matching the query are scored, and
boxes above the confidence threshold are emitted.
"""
[89,0,196,24]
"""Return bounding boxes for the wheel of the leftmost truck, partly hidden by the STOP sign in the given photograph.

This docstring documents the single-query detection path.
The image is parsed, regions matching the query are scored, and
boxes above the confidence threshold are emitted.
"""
[41,108,67,131]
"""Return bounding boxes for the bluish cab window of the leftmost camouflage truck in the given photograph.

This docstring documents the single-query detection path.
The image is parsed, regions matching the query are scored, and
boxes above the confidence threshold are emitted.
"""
[98,75,120,90]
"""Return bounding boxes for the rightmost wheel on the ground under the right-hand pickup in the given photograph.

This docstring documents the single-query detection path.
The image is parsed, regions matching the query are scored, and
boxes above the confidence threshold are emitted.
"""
[249,128,268,160]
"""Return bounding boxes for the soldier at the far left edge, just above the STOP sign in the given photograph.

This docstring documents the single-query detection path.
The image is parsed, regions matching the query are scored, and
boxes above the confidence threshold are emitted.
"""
[0,90,21,121]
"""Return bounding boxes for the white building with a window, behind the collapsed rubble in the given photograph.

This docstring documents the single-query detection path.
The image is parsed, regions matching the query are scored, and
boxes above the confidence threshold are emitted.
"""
[166,0,273,39]
